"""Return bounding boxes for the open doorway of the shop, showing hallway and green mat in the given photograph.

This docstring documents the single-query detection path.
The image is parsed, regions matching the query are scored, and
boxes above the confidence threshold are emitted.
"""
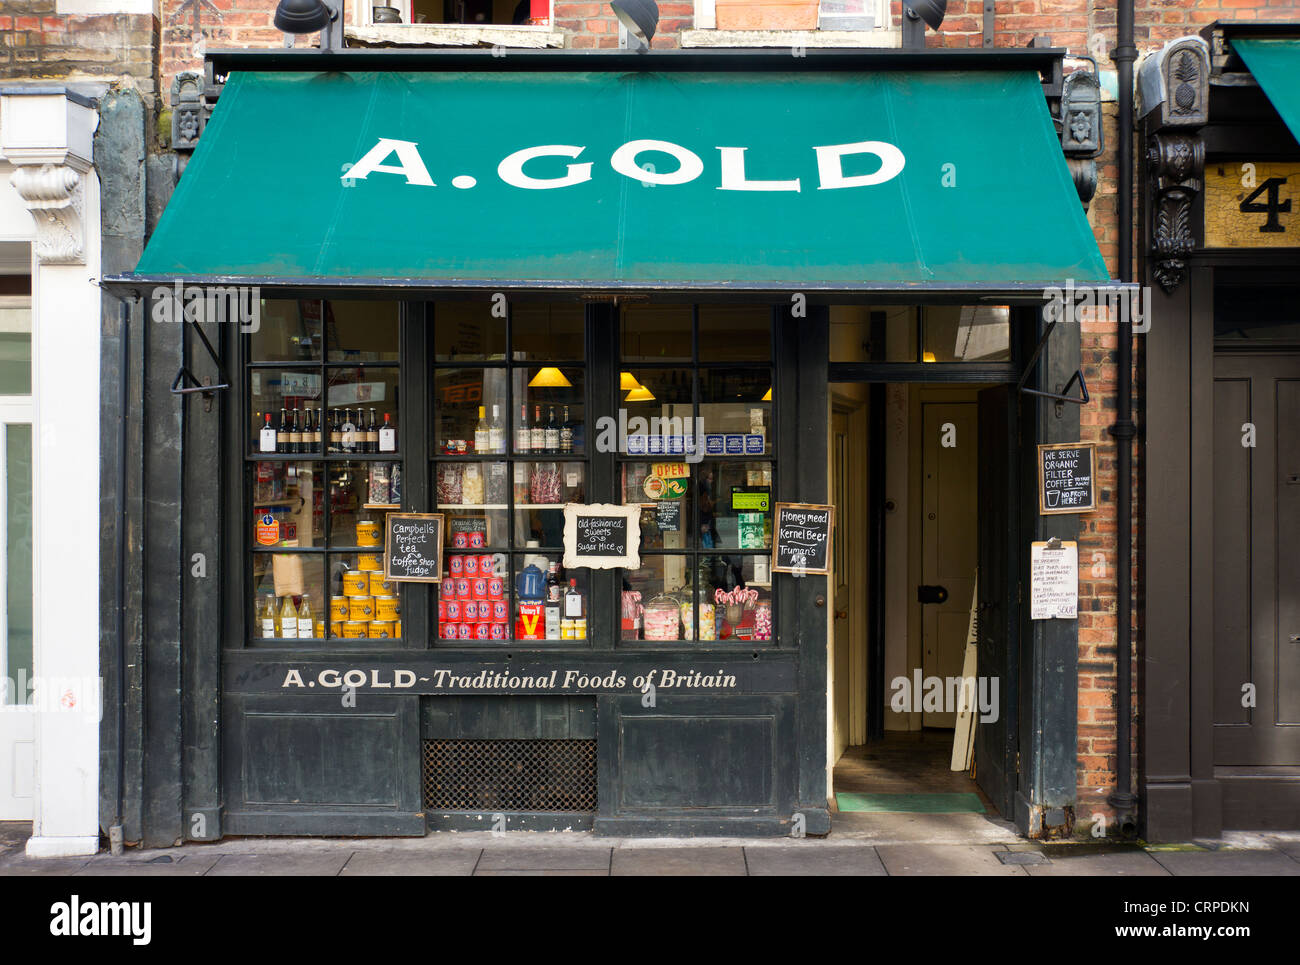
[828,382,1014,826]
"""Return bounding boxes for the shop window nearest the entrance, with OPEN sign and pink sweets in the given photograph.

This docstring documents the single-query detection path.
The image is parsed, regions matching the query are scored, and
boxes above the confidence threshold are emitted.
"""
[616,306,776,645]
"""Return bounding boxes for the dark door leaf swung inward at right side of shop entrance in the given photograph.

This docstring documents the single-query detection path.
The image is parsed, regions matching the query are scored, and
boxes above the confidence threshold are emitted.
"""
[967,385,1021,818]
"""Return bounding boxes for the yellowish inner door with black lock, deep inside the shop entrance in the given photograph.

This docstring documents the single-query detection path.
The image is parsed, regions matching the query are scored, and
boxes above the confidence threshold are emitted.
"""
[920,402,979,727]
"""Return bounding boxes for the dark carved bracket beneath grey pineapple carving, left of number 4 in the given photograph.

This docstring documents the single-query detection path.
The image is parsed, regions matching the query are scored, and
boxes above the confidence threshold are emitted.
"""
[1147,134,1205,291]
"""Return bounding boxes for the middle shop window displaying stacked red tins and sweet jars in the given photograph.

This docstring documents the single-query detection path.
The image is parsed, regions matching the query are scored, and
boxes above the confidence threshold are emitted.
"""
[432,302,592,646]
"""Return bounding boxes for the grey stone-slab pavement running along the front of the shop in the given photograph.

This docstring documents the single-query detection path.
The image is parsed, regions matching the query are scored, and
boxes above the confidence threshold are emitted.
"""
[0,814,1300,878]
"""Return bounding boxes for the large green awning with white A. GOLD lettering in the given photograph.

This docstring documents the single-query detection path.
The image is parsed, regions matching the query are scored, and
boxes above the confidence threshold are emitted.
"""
[134,70,1109,290]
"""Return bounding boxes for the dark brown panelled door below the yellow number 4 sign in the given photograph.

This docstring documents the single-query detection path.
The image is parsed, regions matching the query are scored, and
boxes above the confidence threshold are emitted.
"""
[1212,354,1300,780]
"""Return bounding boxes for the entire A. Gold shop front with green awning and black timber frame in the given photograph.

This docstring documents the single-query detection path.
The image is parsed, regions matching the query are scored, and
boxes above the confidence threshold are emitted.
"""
[105,51,1108,844]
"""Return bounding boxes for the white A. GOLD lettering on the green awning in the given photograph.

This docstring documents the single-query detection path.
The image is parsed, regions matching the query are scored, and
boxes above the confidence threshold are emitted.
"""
[342,138,906,191]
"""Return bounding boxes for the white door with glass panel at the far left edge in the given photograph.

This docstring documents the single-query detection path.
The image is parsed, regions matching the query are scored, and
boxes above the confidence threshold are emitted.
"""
[0,397,35,821]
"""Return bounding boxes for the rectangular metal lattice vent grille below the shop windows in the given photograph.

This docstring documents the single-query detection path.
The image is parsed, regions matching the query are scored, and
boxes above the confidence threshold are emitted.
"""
[424,740,595,812]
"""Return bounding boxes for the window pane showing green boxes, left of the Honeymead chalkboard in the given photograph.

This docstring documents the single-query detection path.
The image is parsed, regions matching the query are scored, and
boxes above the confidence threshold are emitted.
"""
[696,462,772,550]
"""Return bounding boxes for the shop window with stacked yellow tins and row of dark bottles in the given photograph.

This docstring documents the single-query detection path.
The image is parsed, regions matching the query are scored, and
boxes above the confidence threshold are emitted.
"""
[244,299,403,646]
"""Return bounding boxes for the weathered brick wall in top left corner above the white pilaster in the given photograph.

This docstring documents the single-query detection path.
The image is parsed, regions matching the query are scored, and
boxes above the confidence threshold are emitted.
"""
[0,0,157,103]
